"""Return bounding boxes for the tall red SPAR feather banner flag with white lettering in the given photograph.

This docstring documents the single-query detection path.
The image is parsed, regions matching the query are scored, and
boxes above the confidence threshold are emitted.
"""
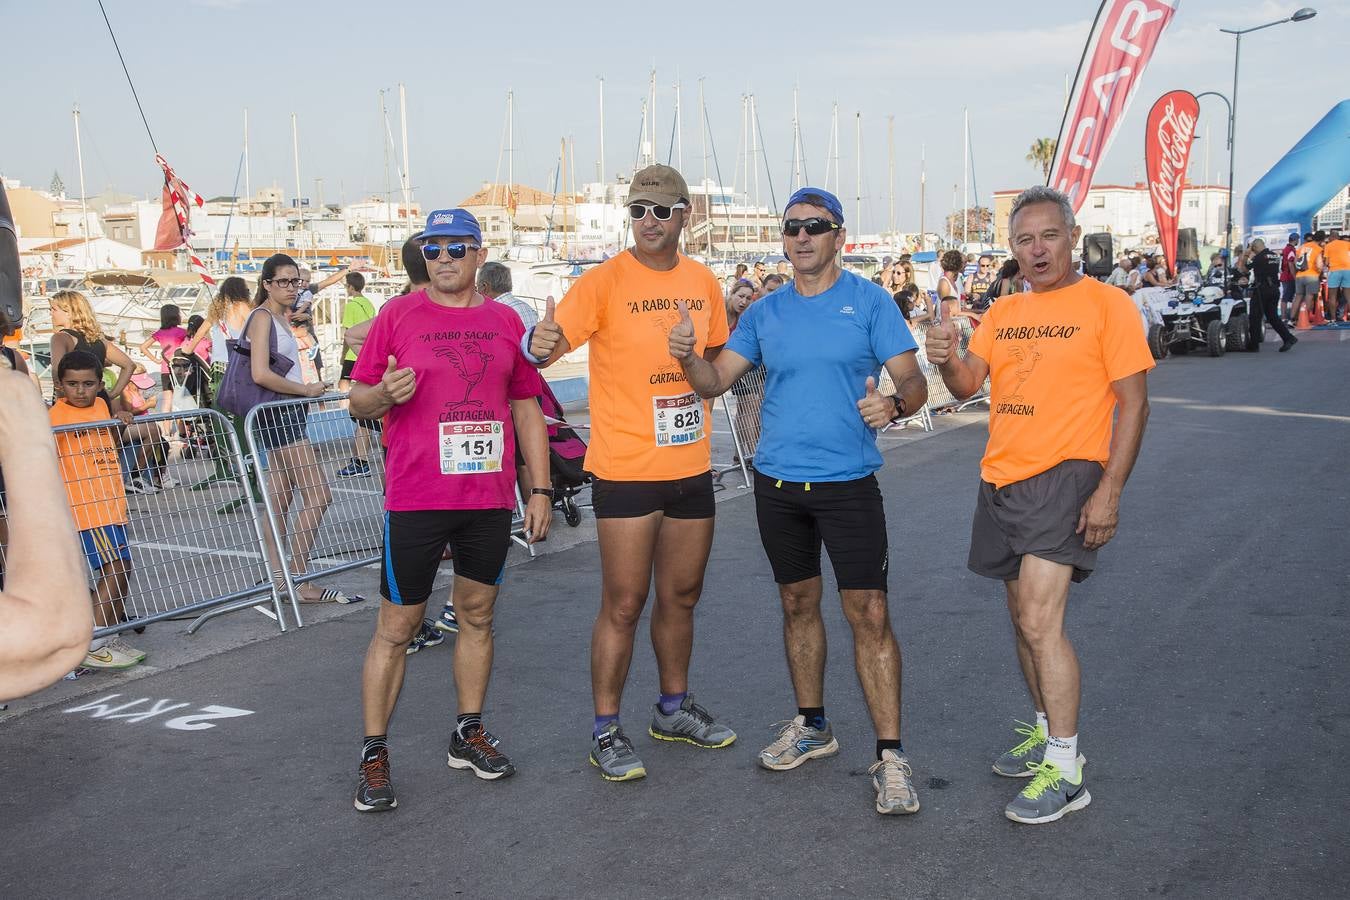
[1050,0,1181,212]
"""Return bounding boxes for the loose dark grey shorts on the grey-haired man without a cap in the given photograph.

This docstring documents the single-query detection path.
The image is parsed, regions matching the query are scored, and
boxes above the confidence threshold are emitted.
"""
[967,459,1102,582]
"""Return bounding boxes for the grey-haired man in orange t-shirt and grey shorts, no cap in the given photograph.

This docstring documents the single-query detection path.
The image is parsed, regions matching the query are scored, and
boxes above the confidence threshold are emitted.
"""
[927,186,1153,824]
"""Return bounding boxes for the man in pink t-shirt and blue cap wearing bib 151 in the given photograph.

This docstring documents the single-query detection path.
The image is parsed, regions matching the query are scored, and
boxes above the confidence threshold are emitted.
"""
[351,209,552,812]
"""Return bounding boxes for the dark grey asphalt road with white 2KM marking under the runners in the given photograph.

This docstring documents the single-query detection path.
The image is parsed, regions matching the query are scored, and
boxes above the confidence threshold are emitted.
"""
[0,327,1350,897]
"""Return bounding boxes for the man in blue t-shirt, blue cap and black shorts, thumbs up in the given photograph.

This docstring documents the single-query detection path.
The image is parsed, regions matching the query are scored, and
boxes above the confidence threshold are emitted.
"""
[670,188,927,814]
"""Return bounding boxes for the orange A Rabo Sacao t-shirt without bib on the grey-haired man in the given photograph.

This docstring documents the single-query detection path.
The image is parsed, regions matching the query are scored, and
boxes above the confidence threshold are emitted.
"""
[971,278,1154,487]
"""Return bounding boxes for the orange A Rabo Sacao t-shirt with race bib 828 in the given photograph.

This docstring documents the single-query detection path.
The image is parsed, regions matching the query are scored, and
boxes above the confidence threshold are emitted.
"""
[556,251,728,482]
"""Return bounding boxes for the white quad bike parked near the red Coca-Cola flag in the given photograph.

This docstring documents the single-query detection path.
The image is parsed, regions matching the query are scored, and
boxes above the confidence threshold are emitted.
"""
[1149,269,1251,359]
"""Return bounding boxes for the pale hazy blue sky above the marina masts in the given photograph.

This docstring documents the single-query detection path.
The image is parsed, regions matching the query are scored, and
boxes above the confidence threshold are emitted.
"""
[0,0,1350,233]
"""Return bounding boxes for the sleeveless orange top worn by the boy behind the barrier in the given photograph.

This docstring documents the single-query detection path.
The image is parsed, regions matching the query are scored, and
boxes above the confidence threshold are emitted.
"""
[47,397,127,532]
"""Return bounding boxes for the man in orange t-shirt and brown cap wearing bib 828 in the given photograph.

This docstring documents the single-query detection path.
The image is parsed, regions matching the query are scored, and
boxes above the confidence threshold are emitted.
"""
[522,165,736,781]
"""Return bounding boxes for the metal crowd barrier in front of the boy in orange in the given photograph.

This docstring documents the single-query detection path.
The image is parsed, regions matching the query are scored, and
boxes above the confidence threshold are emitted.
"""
[35,409,286,637]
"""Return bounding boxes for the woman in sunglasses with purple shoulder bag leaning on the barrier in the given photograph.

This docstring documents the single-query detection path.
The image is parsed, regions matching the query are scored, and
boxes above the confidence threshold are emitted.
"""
[244,254,347,603]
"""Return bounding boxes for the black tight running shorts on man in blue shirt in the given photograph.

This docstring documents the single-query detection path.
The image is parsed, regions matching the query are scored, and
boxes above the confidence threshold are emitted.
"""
[755,472,888,591]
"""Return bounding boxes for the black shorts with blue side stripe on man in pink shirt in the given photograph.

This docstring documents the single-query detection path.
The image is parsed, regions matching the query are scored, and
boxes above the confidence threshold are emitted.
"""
[379,510,512,606]
